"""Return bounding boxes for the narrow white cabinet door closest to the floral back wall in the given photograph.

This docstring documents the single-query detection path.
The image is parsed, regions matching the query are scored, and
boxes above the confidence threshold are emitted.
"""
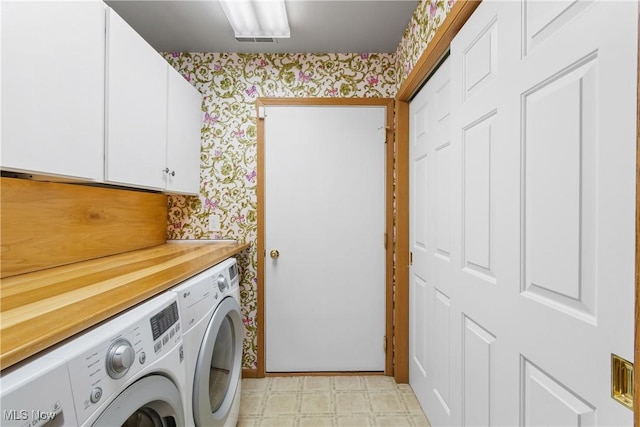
[167,65,202,194]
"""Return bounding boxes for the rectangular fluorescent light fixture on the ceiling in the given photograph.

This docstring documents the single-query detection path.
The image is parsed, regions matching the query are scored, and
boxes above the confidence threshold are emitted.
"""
[220,0,290,38]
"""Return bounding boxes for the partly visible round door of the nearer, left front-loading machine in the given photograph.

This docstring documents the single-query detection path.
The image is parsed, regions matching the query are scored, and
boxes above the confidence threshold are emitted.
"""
[92,375,184,427]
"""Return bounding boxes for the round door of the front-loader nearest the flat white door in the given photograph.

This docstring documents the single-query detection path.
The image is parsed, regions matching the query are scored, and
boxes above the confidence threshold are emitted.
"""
[193,297,242,426]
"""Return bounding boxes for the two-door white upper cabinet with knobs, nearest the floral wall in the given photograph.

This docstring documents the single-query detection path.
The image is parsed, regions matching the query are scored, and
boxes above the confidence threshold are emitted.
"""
[105,10,202,194]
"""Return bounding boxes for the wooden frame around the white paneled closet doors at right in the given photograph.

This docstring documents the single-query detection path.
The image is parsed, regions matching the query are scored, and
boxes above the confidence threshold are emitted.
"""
[394,0,640,427]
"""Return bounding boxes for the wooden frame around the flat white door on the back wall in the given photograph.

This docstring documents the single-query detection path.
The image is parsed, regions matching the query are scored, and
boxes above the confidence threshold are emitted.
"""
[255,98,395,378]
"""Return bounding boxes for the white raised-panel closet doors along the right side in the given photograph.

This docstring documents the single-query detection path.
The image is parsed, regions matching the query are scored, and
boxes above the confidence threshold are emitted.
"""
[410,1,638,426]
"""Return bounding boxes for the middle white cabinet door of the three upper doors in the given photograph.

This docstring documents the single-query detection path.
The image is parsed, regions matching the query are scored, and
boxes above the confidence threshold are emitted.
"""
[105,9,167,190]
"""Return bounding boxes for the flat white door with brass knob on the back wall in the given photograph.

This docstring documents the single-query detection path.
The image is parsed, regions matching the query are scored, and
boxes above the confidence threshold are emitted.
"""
[264,106,386,372]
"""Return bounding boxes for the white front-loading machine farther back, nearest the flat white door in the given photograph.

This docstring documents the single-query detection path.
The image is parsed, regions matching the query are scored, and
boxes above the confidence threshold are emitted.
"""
[172,258,244,427]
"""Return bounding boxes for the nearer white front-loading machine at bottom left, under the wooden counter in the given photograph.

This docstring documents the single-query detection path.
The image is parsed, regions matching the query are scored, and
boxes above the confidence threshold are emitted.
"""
[0,292,186,427]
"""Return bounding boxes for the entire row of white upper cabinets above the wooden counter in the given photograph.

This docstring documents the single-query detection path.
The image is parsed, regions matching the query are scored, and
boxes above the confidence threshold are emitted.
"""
[0,0,202,194]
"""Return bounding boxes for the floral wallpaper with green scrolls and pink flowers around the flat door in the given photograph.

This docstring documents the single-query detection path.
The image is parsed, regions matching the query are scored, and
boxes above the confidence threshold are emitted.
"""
[165,0,453,369]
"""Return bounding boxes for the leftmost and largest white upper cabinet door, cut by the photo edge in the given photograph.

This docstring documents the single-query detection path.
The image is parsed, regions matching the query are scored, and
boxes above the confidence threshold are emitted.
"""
[1,1,105,181]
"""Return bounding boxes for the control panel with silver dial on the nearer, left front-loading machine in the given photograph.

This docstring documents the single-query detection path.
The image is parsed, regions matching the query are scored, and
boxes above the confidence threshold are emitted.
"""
[43,292,182,424]
